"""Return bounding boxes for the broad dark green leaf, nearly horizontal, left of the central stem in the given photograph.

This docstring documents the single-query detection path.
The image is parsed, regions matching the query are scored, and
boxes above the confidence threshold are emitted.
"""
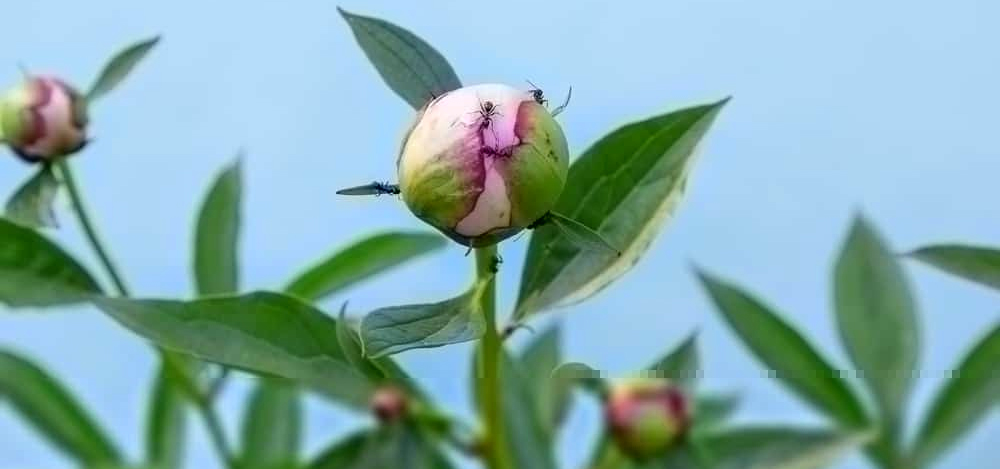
[94,292,372,408]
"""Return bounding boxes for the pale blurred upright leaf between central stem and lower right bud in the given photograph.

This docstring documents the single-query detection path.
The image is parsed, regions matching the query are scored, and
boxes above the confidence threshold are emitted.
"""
[518,326,572,441]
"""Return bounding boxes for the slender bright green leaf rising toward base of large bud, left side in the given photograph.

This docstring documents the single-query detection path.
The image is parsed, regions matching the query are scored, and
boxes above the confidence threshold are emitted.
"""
[286,232,446,300]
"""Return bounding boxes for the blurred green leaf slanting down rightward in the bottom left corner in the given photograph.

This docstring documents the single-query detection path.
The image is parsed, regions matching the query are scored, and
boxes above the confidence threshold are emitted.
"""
[0,350,120,465]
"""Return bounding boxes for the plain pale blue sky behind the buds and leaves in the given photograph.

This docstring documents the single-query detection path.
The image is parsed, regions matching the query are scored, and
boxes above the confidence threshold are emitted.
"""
[0,0,1000,469]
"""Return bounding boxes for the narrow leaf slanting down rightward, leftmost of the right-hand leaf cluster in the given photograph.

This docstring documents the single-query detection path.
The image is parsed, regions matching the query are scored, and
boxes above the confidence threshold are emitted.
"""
[698,272,868,427]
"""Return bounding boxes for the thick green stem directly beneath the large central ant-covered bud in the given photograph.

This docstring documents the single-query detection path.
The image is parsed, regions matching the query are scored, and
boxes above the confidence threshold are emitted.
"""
[476,246,511,469]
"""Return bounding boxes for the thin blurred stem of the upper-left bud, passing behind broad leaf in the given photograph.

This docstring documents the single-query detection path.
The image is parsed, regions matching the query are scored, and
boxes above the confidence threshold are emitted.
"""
[56,159,236,468]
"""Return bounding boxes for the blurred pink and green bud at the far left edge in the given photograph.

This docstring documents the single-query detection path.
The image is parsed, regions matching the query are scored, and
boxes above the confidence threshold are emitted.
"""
[0,76,87,162]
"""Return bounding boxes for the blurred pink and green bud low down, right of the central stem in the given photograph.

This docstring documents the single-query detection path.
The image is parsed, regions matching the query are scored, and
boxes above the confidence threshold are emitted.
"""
[605,379,691,460]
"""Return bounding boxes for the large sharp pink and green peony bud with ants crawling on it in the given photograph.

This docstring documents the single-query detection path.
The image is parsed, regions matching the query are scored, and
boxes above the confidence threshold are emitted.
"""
[398,84,569,247]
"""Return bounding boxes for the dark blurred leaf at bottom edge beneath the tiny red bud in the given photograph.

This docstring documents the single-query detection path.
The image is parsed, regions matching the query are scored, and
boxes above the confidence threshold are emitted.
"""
[307,425,453,469]
